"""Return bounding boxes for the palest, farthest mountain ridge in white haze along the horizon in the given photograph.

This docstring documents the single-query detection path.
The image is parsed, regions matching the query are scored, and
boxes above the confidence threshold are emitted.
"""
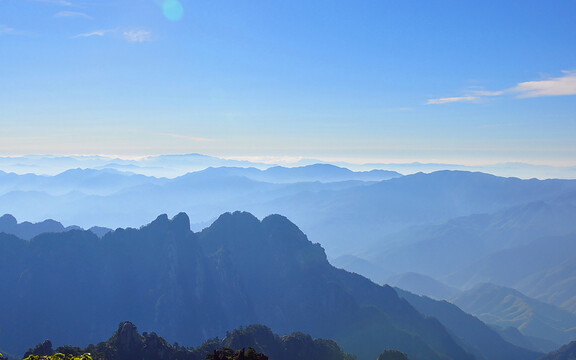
[0,153,576,179]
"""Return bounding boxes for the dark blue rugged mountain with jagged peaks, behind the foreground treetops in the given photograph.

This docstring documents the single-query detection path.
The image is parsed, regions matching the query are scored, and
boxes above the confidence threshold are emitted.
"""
[0,212,533,360]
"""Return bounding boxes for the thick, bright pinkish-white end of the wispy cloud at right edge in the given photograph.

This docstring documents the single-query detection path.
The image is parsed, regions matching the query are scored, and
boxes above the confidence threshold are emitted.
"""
[510,70,576,98]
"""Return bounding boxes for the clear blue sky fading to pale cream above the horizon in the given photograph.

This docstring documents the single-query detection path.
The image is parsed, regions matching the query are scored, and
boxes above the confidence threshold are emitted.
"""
[0,0,576,166]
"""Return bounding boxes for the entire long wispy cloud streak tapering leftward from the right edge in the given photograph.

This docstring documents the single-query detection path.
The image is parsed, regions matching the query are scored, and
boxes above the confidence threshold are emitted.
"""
[426,70,576,105]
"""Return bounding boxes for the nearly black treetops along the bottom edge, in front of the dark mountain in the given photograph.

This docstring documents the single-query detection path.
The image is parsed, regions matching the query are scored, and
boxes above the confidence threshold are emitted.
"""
[25,321,356,360]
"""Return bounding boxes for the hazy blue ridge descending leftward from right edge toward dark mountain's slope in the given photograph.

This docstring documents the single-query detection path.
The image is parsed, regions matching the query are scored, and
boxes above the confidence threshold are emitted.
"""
[359,196,576,287]
